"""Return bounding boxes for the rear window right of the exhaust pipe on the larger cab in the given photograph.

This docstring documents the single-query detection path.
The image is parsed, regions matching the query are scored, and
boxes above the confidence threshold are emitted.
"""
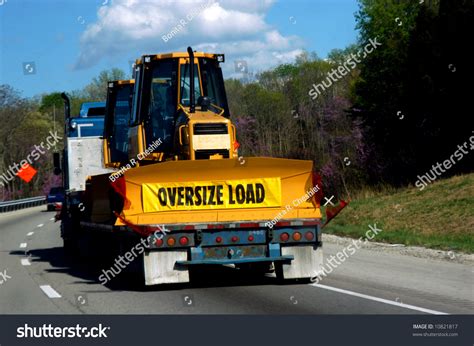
[199,58,230,117]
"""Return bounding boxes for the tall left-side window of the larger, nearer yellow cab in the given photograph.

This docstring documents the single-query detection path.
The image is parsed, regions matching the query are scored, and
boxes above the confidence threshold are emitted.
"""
[145,59,176,152]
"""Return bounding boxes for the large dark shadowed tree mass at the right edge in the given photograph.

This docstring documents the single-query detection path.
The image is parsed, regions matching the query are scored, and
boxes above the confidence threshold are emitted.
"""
[354,0,474,185]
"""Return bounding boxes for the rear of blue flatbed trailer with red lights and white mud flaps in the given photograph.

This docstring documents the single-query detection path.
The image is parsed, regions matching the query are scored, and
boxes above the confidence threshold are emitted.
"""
[81,219,322,285]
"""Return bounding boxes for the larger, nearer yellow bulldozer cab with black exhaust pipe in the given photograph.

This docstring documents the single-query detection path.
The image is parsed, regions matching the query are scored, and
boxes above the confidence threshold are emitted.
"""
[128,50,235,162]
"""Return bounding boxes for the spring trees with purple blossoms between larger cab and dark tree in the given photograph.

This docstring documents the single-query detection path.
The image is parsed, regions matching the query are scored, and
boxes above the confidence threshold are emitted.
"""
[226,48,365,195]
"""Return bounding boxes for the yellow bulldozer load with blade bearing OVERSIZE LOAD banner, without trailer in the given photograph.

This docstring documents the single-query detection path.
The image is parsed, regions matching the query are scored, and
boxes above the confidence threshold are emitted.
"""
[87,48,321,237]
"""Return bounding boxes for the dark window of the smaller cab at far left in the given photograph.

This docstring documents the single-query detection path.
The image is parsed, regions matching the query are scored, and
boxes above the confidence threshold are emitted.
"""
[109,85,132,162]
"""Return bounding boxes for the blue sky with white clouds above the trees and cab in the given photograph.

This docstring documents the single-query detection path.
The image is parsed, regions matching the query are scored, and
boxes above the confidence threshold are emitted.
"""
[0,0,357,97]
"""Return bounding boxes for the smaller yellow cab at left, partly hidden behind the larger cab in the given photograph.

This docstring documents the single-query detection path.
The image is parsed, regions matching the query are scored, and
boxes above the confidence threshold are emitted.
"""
[103,80,135,167]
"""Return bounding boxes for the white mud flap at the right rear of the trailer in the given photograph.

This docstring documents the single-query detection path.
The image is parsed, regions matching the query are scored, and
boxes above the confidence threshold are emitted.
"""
[281,246,323,279]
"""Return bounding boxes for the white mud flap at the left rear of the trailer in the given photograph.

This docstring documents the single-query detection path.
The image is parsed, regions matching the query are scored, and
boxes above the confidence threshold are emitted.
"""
[143,251,189,286]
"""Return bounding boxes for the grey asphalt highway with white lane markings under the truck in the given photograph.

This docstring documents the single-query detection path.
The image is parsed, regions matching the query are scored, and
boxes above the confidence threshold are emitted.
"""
[0,206,474,314]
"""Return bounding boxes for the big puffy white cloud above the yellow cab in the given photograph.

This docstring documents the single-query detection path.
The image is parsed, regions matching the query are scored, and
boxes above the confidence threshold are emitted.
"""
[75,0,303,77]
